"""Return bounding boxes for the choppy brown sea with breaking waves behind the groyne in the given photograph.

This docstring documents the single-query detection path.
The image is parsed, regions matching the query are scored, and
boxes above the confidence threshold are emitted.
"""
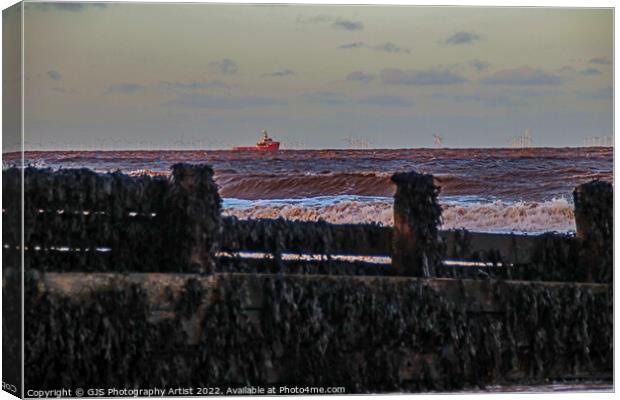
[8,147,613,234]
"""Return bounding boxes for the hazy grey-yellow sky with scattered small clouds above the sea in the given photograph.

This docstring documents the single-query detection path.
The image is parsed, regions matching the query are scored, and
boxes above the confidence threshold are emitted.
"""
[4,3,613,150]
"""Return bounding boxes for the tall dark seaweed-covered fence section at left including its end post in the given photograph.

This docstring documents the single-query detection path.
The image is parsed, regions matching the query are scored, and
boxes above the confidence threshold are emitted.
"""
[2,164,221,271]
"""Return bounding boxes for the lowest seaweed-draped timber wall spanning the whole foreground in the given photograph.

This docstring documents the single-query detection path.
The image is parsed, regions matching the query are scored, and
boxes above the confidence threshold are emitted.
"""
[26,273,613,393]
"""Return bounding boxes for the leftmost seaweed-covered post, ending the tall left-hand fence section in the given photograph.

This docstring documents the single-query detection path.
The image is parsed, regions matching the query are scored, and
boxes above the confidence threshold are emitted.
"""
[163,164,221,273]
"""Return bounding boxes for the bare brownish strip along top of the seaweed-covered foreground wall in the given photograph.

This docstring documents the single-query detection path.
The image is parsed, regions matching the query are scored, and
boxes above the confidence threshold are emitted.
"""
[40,272,608,312]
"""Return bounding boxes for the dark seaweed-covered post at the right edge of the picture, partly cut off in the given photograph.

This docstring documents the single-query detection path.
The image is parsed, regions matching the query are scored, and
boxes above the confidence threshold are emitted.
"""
[573,180,614,283]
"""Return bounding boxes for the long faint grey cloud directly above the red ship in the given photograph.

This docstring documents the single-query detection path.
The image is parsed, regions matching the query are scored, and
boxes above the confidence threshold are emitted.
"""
[165,93,285,110]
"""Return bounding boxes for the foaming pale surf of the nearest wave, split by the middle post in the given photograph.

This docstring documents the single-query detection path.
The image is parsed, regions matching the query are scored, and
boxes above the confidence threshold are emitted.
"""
[223,198,575,233]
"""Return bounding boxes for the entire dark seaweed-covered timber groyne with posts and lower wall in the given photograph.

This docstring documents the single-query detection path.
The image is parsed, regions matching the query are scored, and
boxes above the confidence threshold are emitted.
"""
[3,165,613,394]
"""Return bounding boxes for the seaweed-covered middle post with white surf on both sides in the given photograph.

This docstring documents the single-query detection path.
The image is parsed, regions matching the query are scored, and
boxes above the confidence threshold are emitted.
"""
[392,172,442,277]
